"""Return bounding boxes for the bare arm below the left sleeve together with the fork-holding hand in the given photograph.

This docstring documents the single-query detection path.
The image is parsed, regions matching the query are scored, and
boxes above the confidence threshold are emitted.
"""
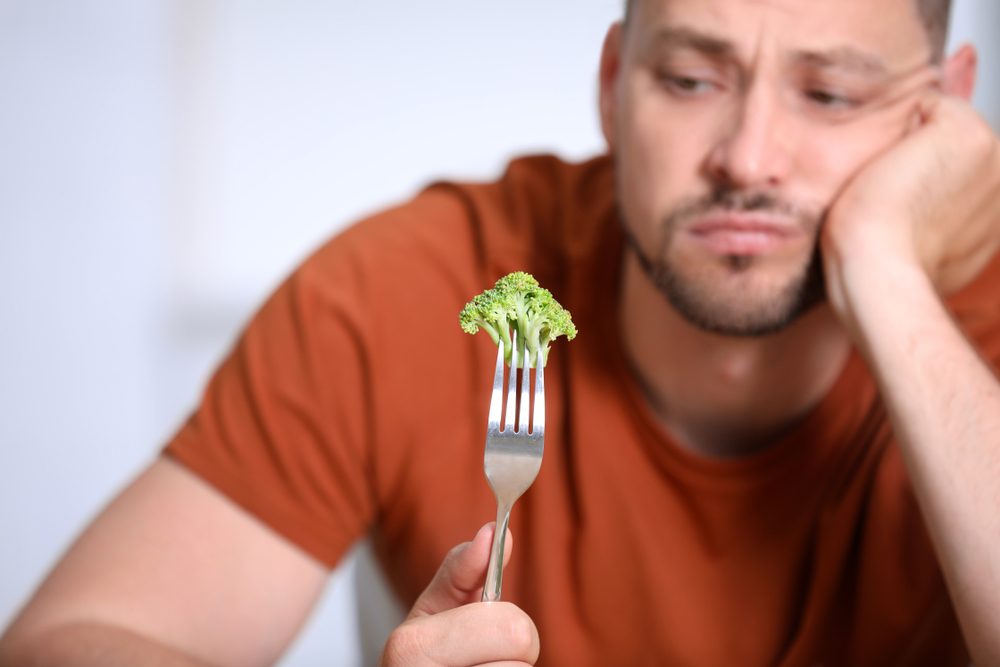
[0,459,538,667]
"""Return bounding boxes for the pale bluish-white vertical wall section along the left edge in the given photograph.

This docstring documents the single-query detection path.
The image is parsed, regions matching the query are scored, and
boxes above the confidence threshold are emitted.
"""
[0,0,170,640]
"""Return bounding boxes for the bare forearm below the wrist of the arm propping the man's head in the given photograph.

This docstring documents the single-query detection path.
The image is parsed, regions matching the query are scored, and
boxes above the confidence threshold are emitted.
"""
[843,256,1000,667]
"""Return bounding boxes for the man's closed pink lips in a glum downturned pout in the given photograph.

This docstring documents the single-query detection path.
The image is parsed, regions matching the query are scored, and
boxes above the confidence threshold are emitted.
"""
[687,213,803,256]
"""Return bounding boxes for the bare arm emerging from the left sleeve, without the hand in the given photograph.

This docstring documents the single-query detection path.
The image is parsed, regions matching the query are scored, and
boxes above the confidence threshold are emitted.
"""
[0,459,327,667]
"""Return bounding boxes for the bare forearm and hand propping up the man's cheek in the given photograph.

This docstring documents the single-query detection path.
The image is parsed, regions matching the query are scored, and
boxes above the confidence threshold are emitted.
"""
[823,87,1000,667]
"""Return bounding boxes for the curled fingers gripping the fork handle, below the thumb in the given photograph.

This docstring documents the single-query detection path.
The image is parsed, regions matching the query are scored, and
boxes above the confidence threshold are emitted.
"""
[381,602,539,667]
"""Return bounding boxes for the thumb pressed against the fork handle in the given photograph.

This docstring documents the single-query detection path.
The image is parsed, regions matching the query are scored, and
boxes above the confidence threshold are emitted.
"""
[406,522,513,620]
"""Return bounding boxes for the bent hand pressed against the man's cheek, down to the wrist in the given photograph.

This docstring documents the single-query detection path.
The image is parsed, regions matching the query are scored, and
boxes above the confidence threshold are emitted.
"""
[822,90,1000,339]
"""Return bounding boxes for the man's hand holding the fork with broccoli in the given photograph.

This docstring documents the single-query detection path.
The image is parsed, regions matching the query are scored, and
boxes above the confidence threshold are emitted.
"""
[379,524,539,667]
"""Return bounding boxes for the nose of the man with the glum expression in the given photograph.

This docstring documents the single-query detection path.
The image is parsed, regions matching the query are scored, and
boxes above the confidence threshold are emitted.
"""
[707,82,792,190]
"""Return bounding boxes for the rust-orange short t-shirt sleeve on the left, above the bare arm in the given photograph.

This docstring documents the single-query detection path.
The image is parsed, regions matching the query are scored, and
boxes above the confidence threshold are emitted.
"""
[166,248,375,566]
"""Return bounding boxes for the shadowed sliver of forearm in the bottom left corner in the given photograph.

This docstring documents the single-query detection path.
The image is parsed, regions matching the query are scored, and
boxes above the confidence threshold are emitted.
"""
[0,623,206,667]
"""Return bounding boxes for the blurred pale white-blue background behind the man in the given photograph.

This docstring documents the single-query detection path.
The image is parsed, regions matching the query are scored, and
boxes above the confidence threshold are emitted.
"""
[0,0,1000,667]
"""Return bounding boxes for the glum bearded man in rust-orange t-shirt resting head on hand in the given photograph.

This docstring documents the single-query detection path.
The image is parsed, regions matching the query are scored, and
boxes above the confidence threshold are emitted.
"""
[0,0,1000,667]
